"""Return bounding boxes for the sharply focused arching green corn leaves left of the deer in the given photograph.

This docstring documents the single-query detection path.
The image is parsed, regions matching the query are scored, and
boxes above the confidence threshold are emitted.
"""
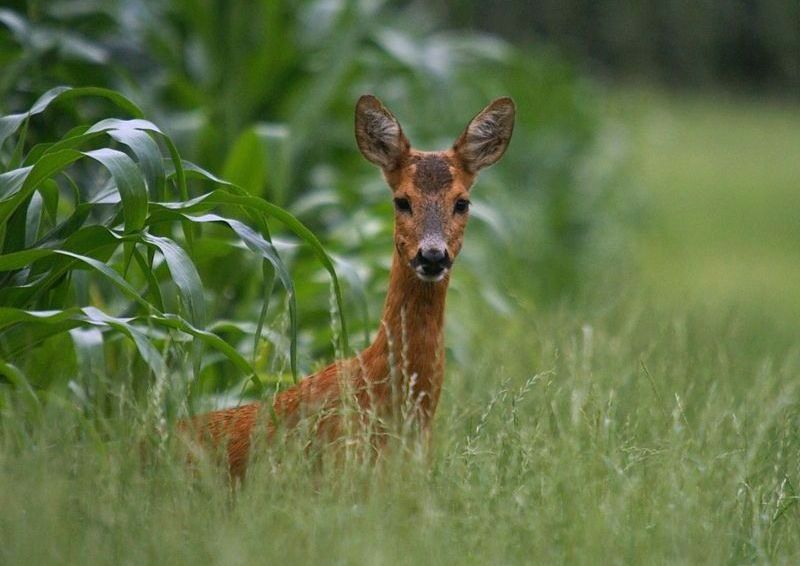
[0,87,348,412]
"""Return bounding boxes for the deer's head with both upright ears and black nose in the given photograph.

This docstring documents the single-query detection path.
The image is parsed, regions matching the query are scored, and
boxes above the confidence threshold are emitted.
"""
[356,95,515,283]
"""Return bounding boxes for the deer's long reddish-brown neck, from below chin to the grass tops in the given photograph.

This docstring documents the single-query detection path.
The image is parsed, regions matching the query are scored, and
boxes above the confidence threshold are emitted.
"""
[363,252,450,416]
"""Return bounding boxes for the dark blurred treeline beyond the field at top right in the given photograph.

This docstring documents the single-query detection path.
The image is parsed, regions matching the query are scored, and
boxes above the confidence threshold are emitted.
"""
[438,0,800,92]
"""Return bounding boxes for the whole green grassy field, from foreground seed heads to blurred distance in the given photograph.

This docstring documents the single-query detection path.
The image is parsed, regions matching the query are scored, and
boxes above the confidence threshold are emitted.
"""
[0,89,800,564]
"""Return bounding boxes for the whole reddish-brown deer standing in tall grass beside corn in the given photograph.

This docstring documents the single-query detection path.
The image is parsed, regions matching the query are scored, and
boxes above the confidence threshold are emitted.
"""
[180,94,516,480]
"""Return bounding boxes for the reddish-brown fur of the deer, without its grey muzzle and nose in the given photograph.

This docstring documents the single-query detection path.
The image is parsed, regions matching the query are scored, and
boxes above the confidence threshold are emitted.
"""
[181,97,513,478]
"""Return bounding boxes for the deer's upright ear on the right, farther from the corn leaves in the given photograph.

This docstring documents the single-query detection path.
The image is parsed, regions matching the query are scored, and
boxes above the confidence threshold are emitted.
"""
[453,97,516,173]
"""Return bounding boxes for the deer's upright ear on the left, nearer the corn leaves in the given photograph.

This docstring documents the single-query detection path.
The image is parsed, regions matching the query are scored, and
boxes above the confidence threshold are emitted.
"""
[356,94,411,171]
